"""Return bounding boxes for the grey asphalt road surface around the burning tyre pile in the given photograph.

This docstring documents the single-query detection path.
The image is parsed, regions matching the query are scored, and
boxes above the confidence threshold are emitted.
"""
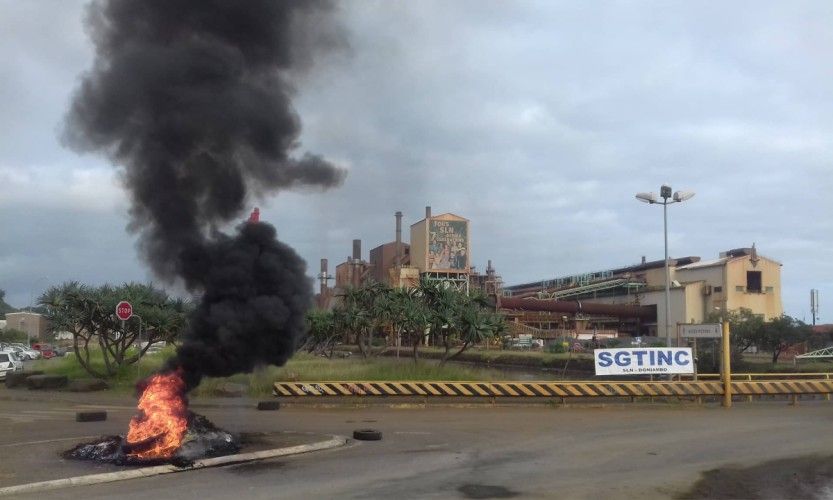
[0,398,833,500]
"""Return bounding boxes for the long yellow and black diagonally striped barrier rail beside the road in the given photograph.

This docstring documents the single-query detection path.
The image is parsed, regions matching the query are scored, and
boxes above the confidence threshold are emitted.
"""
[273,379,833,398]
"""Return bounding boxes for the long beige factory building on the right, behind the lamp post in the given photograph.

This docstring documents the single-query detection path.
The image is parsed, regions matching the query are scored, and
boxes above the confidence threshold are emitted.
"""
[502,245,783,337]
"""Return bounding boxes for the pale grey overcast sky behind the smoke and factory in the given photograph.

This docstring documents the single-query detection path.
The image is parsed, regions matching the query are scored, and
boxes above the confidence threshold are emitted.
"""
[0,0,833,323]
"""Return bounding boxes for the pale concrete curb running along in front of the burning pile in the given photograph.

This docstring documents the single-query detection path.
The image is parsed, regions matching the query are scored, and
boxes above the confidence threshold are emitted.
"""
[0,436,347,497]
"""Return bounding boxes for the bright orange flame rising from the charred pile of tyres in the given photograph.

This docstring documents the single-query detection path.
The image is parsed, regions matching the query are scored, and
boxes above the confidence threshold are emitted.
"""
[127,370,188,459]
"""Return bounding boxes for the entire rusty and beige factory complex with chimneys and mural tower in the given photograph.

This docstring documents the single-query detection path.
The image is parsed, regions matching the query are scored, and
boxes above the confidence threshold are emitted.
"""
[318,207,783,339]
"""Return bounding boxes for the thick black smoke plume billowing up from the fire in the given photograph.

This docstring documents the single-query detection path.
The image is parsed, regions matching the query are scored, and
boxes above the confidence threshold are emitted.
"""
[65,0,344,388]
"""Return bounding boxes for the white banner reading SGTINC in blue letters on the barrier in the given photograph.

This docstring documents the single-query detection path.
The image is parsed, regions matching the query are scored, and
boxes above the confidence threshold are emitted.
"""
[593,347,694,375]
